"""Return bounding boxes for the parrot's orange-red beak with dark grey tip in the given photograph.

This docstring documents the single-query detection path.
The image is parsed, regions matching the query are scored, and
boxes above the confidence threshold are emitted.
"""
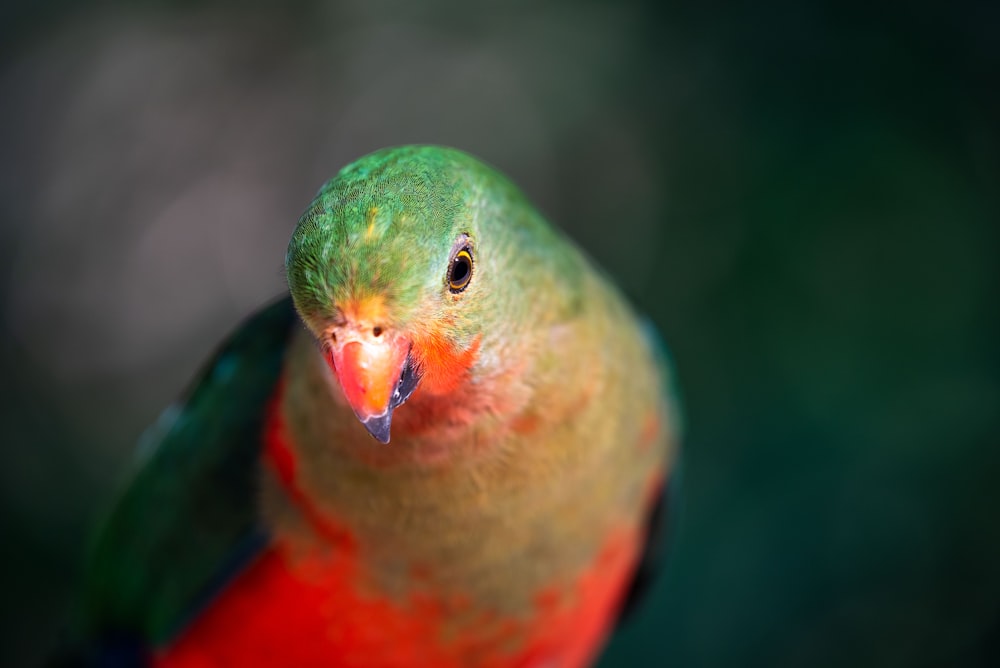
[330,328,420,443]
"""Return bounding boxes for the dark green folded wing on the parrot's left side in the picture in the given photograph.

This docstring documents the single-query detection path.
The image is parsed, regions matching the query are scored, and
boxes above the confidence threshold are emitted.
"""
[84,298,297,645]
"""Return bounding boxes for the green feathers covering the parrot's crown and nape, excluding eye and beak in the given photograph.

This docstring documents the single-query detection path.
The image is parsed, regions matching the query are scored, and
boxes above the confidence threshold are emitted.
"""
[286,146,580,352]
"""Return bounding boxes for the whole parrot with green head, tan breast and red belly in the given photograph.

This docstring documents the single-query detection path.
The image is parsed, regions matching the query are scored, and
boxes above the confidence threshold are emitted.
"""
[68,146,681,668]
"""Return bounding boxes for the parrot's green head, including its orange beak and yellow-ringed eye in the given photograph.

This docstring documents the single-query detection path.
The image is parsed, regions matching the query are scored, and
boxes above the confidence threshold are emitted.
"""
[286,147,524,443]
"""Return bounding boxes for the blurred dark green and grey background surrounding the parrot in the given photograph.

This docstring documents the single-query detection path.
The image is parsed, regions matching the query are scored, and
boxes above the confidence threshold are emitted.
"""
[0,0,1000,666]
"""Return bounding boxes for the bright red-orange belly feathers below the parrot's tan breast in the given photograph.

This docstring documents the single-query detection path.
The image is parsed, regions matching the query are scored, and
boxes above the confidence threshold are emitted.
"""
[154,384,639,668]
